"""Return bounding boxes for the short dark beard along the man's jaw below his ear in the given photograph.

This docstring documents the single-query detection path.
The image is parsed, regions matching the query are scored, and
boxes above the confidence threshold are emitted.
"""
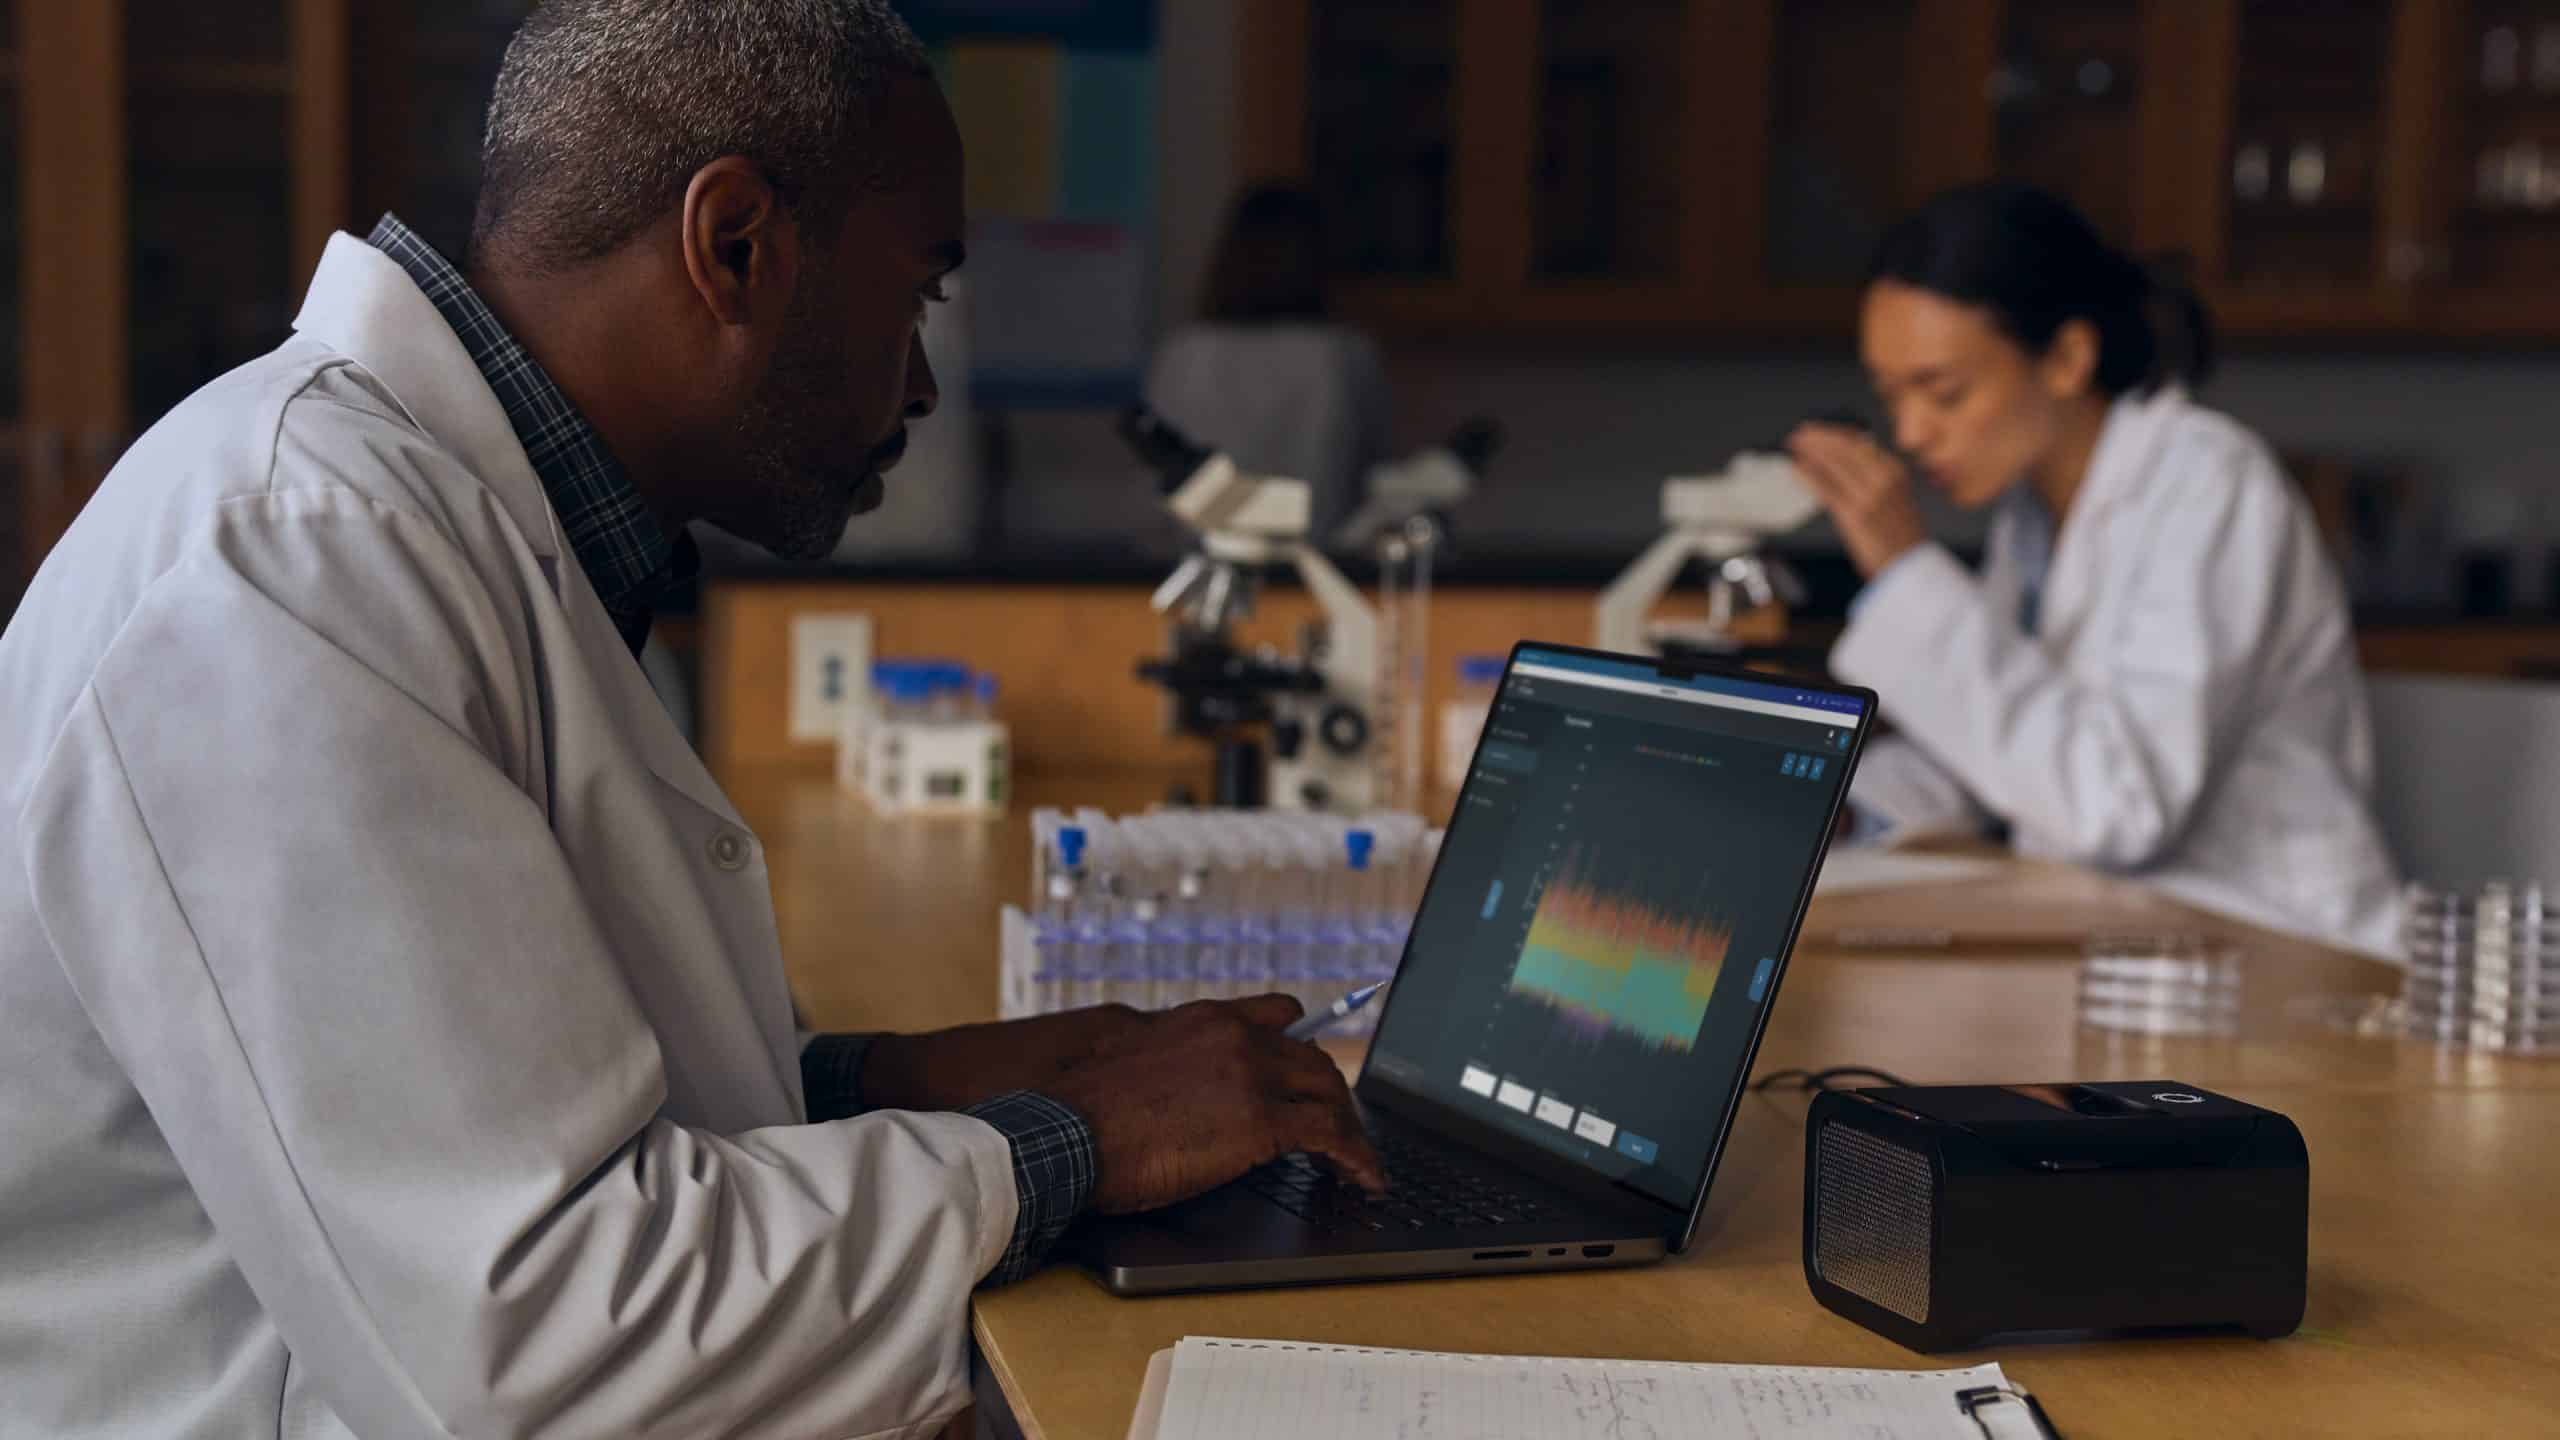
[732,297,881,561]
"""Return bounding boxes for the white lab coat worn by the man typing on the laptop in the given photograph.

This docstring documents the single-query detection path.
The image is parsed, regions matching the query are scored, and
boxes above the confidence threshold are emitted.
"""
[0,236,1016,1440]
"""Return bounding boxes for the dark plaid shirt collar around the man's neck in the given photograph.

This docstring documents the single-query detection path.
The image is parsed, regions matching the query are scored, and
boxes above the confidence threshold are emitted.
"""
[369,215,701,656]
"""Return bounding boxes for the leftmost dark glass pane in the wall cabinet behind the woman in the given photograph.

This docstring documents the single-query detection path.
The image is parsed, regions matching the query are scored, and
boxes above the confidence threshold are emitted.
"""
[1308,0,1457,279]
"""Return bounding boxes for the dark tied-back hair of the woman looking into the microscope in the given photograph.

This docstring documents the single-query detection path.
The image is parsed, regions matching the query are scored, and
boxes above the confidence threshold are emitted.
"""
[1866,182,2214,397]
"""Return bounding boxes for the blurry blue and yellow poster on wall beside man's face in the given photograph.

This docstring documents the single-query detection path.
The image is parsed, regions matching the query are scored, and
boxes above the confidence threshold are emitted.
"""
[899,0,1160,410]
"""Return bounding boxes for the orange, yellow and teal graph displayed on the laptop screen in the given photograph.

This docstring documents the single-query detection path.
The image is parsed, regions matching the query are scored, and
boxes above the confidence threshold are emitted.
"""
[1510,853,1733,1053]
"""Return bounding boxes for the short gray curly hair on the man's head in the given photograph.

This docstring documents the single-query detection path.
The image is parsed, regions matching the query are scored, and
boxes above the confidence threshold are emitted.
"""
[471,0,929,274]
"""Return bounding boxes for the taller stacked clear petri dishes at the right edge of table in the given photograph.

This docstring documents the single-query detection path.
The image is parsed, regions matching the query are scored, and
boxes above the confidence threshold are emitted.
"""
[2399,881,2560,1056]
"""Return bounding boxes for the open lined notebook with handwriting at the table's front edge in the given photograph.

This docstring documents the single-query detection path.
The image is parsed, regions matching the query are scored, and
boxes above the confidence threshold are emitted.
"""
[1129,1335,2058,1440]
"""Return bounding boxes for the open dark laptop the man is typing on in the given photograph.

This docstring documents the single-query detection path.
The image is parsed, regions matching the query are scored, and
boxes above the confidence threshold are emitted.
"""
[1070,643,1876,1294]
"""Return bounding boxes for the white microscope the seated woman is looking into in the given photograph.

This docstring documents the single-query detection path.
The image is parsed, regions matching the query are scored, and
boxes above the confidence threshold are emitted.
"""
[1592,451,1823,659]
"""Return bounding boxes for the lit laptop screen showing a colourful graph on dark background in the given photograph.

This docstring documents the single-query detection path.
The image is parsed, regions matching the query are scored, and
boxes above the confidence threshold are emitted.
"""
[1370,646,1866,1207]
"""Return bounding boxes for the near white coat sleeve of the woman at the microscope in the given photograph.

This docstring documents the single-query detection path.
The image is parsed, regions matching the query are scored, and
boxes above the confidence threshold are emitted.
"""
[1830,456,2289,869]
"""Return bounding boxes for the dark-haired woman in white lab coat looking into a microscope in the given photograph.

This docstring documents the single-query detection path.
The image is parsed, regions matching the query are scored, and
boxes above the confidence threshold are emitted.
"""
[1789,184,2399,956]
